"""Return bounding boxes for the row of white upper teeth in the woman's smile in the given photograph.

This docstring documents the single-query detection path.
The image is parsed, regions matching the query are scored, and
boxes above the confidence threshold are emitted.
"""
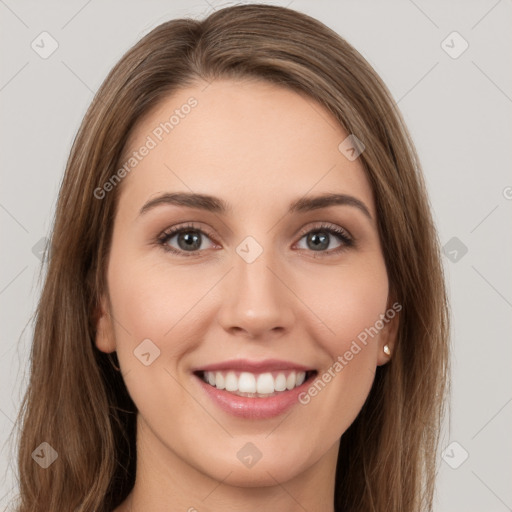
[203,371,306,396]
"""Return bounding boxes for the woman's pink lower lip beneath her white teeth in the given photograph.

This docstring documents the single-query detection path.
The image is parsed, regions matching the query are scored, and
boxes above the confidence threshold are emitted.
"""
[194,375,312,419]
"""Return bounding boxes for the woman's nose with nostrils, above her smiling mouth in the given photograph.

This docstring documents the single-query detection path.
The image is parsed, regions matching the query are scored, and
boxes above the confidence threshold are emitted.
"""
[219,244,300,340]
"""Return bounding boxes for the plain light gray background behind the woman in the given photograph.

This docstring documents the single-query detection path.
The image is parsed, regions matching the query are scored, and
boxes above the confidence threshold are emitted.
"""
[0,0,512,512]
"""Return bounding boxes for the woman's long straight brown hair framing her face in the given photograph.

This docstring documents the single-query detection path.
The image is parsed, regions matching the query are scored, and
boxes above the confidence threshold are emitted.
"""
[9,5,449,512]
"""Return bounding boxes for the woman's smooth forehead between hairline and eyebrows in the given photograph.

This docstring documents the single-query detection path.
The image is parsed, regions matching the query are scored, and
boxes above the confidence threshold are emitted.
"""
[117,80,375,218]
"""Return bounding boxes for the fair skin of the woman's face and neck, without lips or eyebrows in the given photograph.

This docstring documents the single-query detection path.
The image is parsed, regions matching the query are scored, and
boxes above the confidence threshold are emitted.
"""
[96,80,398,512]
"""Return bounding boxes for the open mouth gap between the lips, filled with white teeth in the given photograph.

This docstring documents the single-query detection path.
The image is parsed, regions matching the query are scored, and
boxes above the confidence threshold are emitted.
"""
[194,370,318,398]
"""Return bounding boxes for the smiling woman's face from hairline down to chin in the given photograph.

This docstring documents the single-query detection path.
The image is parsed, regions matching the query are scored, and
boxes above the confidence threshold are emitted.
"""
[95,80,397,486]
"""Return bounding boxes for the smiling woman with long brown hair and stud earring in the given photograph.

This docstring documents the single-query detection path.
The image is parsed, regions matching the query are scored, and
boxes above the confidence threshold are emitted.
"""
[12,5,449,512]
